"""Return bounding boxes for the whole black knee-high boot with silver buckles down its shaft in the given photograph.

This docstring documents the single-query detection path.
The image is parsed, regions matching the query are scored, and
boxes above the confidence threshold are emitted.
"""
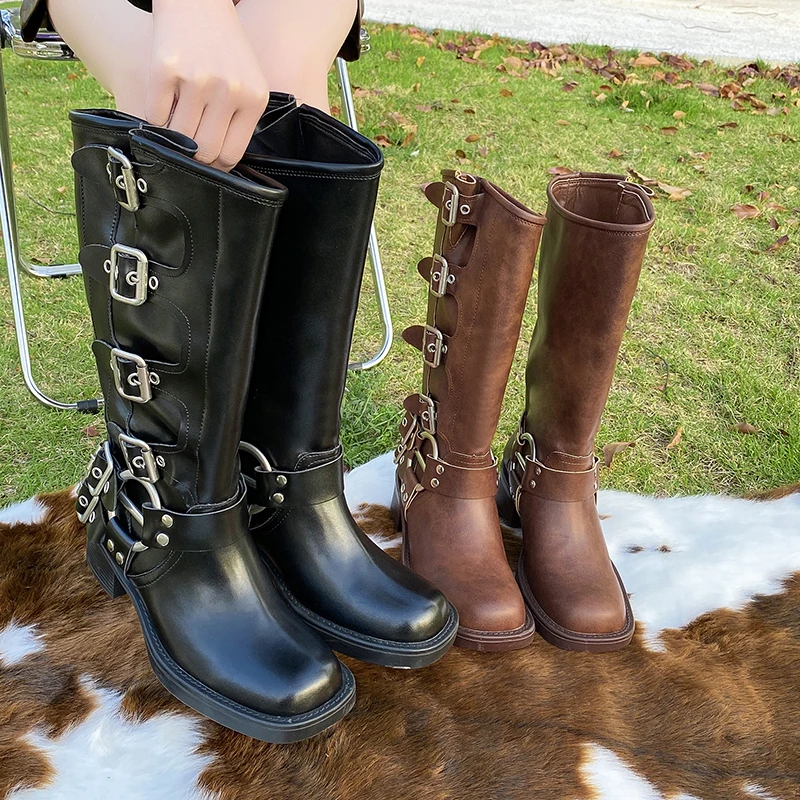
[72,111,354,742]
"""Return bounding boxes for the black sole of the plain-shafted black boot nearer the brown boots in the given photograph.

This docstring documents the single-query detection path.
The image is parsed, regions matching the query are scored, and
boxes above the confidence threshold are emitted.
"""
[261,553,458,669]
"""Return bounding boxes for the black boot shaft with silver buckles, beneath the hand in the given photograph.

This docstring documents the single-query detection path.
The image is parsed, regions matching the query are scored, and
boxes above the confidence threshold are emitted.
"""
[72,112,286,511]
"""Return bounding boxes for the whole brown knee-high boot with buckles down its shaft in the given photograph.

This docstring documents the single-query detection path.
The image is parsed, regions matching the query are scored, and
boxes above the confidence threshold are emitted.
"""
[393,171,545,650]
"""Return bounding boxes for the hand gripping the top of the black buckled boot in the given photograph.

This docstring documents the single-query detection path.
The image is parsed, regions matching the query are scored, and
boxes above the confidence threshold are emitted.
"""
[145,0,269,171]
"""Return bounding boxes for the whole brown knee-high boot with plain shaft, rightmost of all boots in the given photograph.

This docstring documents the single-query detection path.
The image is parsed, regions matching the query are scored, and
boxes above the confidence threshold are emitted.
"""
[498,174,655,652]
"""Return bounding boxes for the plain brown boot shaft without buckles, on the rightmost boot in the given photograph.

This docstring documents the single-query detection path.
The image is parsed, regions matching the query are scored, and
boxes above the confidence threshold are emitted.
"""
[526,174,655,462]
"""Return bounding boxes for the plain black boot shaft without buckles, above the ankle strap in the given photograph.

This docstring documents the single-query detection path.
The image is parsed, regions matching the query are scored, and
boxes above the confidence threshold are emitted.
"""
[243,106,383,469]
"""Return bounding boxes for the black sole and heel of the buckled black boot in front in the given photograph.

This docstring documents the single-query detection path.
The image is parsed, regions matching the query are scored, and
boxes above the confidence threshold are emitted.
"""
[86,542,356,744]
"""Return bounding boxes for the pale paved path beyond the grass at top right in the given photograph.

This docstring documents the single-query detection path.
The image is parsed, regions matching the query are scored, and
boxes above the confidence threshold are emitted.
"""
[366,0,800,63]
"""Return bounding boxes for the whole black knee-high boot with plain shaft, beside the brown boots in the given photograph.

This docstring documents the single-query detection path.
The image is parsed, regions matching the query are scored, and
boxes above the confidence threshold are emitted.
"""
[242,106,458,667]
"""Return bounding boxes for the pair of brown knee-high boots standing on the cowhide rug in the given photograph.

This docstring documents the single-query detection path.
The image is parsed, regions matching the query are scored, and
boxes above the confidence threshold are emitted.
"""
[392,171,655,652]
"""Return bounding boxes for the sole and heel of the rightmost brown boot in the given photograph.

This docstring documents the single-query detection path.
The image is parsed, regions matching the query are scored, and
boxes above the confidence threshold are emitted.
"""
[497,470,636,653]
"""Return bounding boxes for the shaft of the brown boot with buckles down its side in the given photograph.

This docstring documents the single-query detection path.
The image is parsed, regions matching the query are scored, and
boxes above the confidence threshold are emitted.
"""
[404,170,545,466]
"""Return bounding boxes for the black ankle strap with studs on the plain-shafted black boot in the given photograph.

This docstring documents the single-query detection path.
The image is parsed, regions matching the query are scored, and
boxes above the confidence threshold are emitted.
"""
[253,456,344,509]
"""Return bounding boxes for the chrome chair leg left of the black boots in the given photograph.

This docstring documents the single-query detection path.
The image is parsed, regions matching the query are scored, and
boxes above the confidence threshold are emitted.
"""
[0,53,102,414]
